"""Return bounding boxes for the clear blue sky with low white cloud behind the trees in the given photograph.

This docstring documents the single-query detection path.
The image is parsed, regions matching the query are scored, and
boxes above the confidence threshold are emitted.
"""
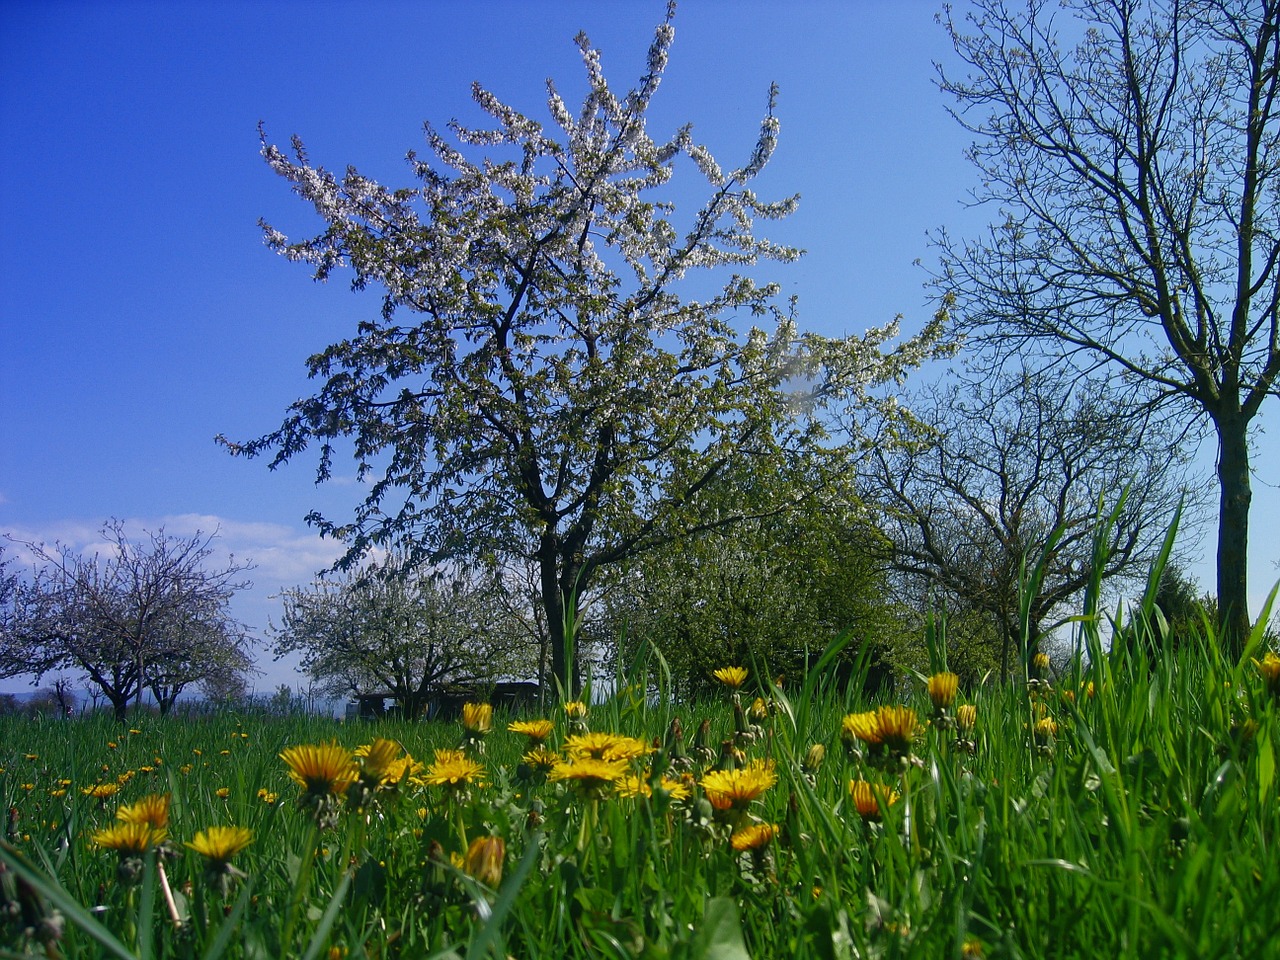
[0,0,1276,689]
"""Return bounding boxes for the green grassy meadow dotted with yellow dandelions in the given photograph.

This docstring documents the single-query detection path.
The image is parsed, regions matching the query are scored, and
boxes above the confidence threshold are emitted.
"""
[0,616,1280,960]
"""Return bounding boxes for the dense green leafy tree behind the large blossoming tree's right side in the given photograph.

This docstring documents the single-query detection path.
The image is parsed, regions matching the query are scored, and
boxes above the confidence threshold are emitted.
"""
[603,475,908,696]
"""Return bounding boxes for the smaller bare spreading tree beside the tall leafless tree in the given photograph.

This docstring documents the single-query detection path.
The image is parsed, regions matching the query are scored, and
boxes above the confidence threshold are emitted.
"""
[865,371,1198,676]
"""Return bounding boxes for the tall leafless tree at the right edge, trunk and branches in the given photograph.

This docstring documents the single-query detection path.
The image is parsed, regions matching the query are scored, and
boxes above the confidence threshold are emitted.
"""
[940,0,1280,650]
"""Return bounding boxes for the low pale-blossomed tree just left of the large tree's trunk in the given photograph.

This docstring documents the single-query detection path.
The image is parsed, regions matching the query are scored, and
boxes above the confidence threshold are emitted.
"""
[271,559,527,717]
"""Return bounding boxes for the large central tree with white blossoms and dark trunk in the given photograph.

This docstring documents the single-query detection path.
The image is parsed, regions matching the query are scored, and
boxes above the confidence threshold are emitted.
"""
[223,10,941,701]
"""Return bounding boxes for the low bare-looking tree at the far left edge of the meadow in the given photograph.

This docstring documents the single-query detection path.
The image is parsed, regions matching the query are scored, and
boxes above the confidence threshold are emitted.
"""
[0,521,257,721]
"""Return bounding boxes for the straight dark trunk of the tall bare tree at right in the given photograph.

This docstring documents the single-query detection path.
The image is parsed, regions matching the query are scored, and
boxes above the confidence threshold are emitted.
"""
[1215,412,1253,659]
